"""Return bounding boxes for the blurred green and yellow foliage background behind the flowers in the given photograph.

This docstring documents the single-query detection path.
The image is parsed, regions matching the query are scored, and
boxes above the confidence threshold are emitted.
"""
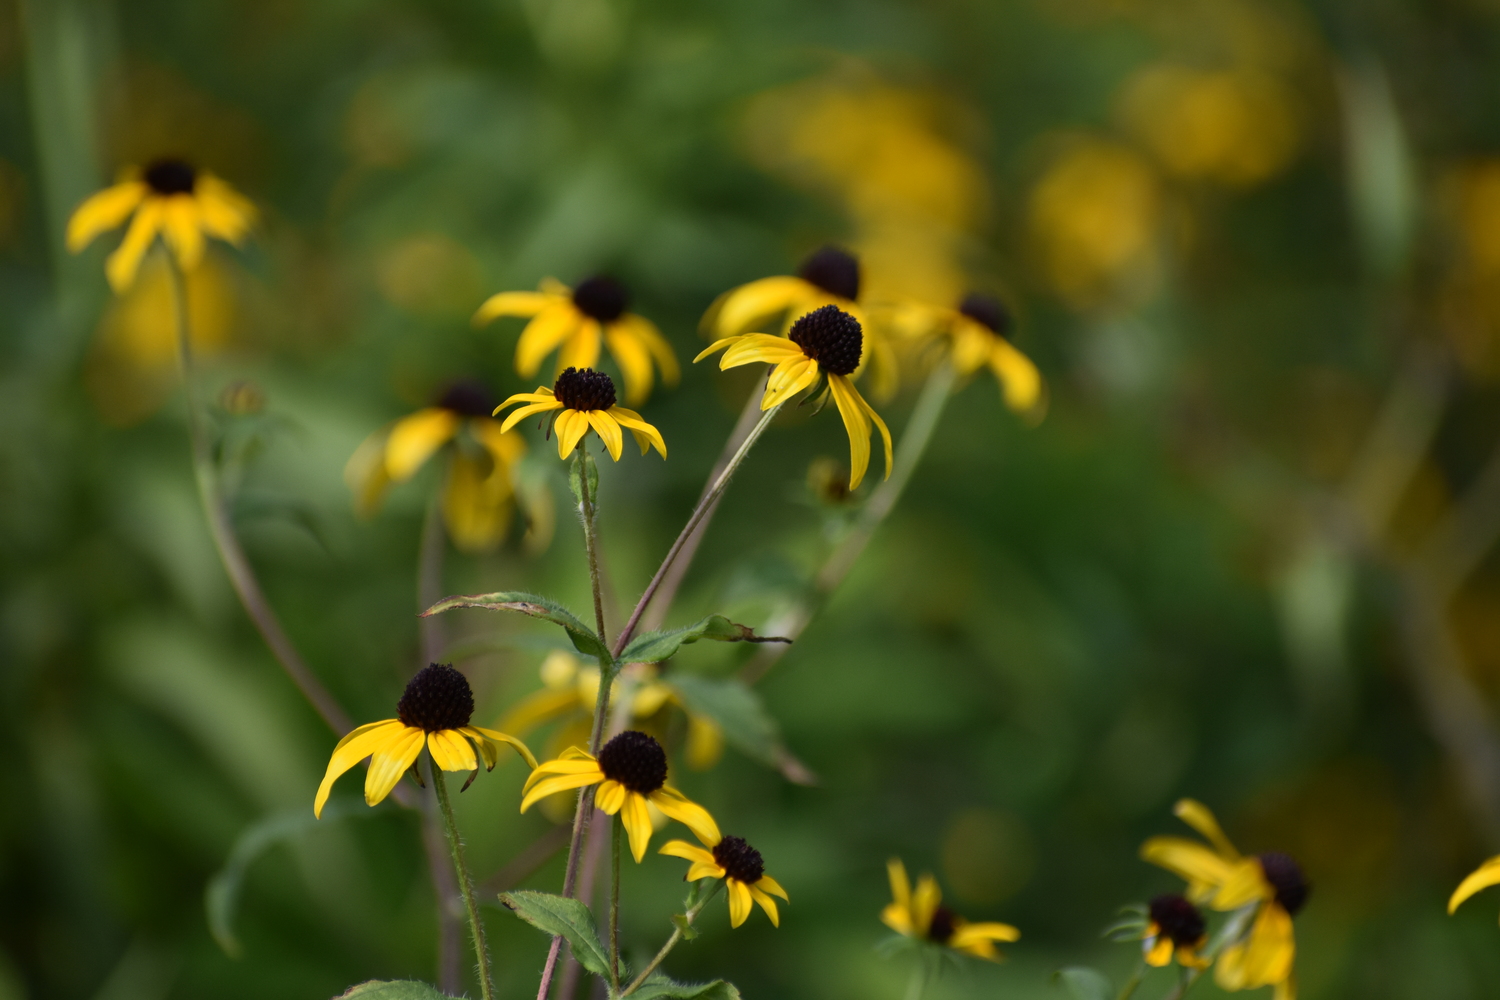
[0,0,1500,1000]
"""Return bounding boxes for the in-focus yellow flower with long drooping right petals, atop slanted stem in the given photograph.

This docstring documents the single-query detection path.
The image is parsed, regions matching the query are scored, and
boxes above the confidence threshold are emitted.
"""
[693,306,891,489]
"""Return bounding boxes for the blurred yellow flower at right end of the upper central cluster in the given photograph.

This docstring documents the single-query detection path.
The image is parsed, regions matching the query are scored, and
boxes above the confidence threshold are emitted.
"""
[893,292,1041,414]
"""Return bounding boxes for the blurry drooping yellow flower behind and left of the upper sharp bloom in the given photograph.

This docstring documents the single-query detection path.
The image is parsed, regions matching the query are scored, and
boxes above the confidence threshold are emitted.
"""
[344,381,527,552]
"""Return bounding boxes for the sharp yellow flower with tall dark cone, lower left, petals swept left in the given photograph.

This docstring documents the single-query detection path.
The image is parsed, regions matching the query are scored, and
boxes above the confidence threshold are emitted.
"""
[312,663,537,816]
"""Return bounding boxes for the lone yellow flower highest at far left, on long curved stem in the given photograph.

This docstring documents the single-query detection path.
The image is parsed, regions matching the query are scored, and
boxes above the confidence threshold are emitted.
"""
[68,159,255,292]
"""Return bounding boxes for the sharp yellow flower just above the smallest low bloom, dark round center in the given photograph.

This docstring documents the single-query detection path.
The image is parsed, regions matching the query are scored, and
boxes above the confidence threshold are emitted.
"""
[521,729,719,862]
